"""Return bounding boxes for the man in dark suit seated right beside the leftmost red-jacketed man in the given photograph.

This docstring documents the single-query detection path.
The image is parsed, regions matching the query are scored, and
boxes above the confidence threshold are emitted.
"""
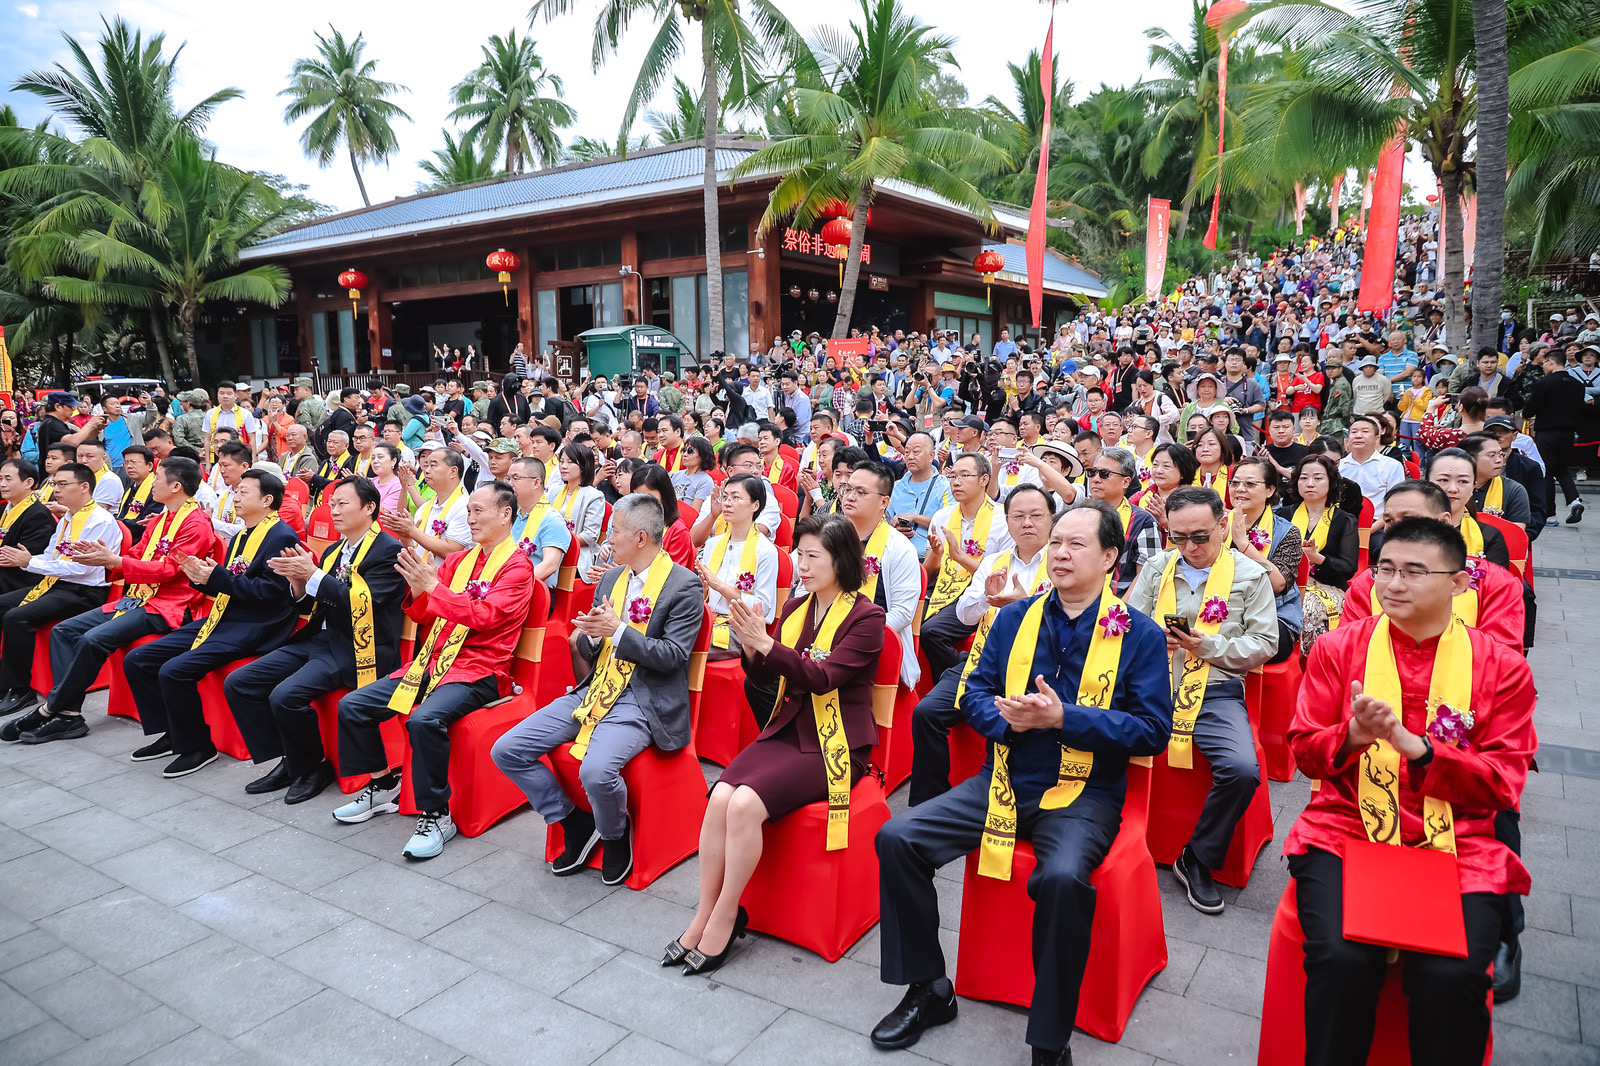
[122,471,299,778]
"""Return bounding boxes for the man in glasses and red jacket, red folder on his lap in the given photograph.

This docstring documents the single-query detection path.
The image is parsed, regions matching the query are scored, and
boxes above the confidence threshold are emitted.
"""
[1283,517,1538,1066]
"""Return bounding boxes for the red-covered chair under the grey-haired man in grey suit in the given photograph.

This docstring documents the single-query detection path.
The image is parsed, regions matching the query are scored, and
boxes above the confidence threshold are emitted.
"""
[540,601,710,890]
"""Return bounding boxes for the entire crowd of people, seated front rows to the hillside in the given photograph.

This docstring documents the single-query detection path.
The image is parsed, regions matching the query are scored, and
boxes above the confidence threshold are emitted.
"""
[0,209,1568,1063]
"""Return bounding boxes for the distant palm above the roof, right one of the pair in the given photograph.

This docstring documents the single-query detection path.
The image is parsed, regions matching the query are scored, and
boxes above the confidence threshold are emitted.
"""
[450,30,578,174]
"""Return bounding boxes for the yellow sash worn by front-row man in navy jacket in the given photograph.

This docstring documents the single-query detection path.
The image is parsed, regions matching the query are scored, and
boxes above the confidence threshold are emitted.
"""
[978,592,1130,880]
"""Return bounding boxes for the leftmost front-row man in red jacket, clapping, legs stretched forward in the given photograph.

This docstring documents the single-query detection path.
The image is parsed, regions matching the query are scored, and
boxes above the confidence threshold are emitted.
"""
[5,456,216,739]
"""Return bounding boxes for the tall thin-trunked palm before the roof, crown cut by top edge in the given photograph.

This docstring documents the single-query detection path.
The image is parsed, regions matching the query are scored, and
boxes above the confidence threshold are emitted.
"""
[528,0,808,351]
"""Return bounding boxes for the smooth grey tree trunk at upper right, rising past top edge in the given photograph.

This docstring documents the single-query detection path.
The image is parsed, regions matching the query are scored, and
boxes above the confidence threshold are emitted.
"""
[1472,0,1510,351]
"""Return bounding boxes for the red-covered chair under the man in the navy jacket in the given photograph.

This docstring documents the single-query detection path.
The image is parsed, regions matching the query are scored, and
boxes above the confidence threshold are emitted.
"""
[955,765,1171,1043]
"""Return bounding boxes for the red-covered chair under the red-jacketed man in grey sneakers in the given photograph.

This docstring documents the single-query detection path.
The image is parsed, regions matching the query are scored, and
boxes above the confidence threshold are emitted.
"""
[395,581,550,837]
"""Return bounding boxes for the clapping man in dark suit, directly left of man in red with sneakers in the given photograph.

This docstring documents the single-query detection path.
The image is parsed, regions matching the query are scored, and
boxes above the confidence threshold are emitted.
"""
[222,477,405,804]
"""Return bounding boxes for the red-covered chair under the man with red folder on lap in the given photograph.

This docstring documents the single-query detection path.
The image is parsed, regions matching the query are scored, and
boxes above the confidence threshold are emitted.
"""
[1256,880,1494,1066]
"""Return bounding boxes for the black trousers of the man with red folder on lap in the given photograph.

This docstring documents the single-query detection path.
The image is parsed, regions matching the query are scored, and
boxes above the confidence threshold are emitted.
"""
[1290,848,1506,1066]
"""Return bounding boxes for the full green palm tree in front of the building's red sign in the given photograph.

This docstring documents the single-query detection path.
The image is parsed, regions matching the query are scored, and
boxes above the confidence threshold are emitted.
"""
[733,0,1011,338]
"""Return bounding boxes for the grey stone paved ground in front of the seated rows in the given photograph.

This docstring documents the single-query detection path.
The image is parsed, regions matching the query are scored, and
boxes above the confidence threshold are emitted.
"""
[0,492,1600,1066]
